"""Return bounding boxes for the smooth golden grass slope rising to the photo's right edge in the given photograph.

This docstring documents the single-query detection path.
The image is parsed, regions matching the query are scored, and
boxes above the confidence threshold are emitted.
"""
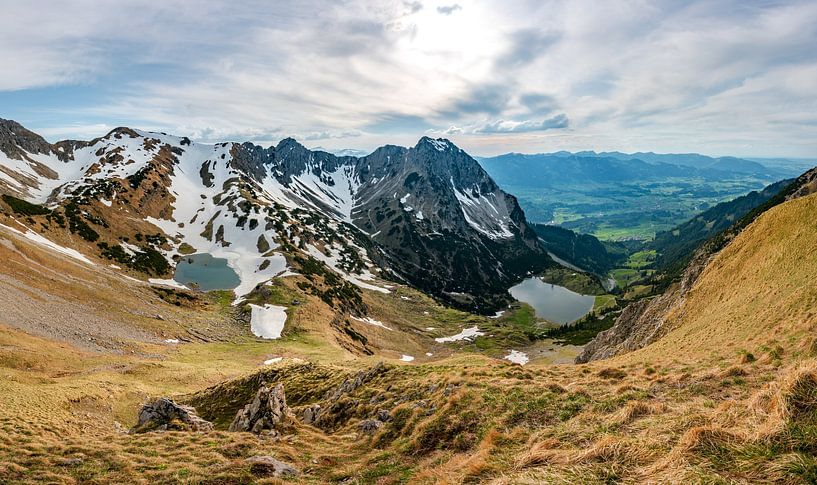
[630,191,817,362]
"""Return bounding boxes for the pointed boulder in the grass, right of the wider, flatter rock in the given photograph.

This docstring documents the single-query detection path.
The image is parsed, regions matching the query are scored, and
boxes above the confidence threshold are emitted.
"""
[229,384,293,435]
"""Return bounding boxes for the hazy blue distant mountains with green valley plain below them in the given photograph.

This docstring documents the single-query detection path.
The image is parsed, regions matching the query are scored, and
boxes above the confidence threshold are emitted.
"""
[479,147,802,241]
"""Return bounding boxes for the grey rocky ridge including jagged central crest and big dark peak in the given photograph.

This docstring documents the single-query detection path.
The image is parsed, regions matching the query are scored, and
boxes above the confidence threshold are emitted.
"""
[233,137,551,312]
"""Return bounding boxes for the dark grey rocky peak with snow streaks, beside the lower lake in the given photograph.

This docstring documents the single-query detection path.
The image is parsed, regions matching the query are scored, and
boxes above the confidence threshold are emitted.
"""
[353,138,550,312]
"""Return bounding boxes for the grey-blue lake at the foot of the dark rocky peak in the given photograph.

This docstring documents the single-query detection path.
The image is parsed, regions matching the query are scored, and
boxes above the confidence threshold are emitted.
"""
[508,277,596,325]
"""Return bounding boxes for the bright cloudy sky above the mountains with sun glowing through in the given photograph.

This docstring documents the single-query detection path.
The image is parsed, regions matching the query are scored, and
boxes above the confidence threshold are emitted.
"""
[0,0,817,158]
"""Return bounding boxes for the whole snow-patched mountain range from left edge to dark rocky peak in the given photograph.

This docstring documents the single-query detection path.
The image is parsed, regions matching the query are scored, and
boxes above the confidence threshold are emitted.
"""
[0,120,553,312]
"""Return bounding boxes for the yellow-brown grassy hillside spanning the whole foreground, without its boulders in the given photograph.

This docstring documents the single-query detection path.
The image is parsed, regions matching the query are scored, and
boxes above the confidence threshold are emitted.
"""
[0,171,817,483]
